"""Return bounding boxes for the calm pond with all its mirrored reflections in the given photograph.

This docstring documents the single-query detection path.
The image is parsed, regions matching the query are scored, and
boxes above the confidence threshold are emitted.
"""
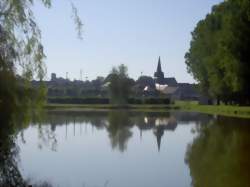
[0,110,250,187]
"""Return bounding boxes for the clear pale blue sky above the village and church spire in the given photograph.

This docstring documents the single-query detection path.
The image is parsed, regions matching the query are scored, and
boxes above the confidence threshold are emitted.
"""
[34,0,222,83]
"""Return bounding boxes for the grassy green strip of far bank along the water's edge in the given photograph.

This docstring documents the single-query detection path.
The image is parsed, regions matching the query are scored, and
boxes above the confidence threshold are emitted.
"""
[45,101,250,118]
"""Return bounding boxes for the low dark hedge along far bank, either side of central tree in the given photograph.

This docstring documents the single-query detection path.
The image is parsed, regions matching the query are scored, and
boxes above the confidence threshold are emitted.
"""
[47,97,170,104]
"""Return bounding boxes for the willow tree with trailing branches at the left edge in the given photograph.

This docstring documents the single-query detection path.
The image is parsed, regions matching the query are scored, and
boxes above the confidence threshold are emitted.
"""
[0,0,83,109]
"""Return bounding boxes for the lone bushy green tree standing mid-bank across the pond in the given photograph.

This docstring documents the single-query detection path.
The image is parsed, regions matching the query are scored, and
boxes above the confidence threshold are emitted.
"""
[107,64,133,104]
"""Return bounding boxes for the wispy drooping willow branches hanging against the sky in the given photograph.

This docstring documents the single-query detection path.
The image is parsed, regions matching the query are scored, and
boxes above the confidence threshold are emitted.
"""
[0,0,83,80]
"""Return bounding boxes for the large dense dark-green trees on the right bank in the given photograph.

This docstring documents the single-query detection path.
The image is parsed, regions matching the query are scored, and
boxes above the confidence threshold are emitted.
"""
[185,0,250,105]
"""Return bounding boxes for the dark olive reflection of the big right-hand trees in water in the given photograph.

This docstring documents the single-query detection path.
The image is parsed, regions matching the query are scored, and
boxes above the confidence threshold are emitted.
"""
[185,117,250,187]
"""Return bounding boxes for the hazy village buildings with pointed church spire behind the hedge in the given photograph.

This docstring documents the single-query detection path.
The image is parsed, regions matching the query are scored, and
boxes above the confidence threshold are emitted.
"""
[32,57,200,100]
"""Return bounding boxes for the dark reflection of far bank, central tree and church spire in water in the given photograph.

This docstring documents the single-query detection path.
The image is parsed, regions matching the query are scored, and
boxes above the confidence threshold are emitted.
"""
[27,110,207,152]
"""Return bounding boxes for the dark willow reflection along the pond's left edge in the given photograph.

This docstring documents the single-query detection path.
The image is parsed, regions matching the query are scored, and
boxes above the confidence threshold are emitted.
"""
[0,108,55,187]
